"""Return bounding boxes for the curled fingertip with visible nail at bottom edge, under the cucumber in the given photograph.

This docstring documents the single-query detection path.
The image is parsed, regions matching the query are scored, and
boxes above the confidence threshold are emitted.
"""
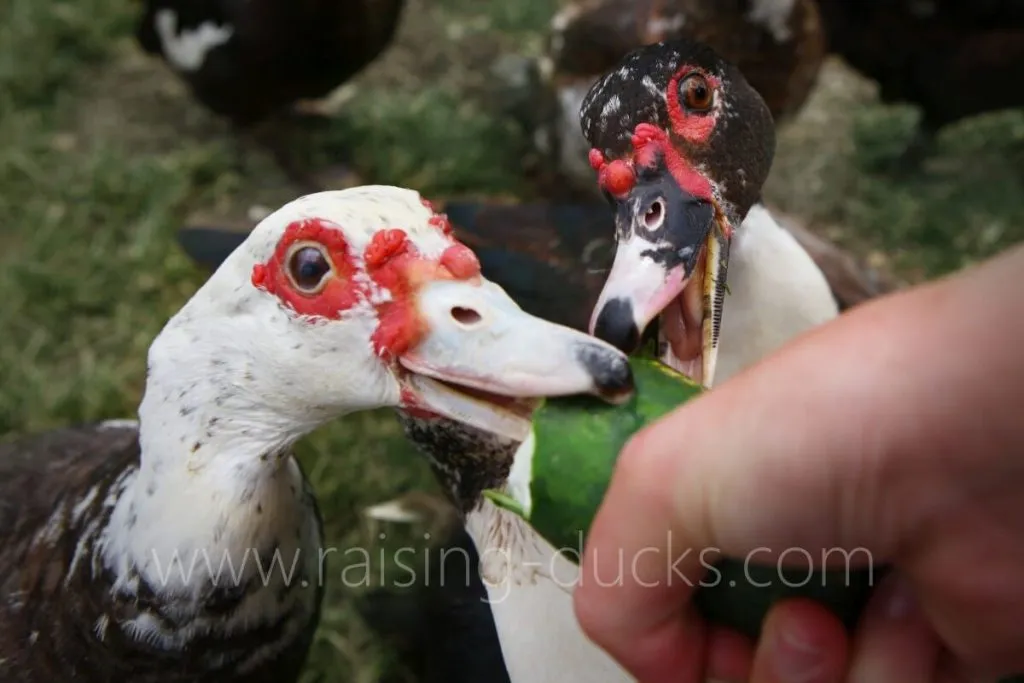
[750,599,851,683]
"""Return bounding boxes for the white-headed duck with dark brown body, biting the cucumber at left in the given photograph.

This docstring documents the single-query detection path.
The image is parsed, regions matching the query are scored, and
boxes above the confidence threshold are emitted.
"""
[0,186,632,683]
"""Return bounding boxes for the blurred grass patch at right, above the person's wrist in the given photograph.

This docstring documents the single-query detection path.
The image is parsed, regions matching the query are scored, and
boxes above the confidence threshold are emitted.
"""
[766,63,1024,282]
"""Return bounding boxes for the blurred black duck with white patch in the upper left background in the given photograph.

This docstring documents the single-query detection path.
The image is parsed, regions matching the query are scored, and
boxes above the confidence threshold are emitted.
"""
[135,0,406,188]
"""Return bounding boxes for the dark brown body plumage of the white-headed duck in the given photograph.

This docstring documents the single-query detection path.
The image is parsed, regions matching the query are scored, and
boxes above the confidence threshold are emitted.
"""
[0,425,323,683]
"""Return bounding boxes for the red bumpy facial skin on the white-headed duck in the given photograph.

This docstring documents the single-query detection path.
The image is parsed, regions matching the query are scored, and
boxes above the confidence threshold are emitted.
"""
[252,216,480,362]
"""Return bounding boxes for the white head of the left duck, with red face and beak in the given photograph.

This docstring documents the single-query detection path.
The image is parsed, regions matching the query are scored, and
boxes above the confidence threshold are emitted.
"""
[156,186,633,448]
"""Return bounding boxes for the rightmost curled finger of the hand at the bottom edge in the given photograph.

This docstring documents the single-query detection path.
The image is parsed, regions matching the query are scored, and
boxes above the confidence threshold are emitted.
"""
[848,574,941,683]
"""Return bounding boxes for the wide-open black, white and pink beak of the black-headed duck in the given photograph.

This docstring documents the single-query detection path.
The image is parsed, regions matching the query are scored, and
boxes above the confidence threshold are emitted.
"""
[590,172,729,387]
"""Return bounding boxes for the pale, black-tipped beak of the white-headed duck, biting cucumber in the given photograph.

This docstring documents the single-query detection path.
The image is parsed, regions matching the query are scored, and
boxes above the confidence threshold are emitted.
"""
[398,279,634,441]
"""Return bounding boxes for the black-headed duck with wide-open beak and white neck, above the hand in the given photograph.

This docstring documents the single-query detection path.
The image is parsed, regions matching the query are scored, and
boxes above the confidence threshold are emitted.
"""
[580,40,838,386]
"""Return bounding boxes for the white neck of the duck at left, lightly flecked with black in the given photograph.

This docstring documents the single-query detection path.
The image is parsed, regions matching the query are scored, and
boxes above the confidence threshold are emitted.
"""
[100,313,317,608]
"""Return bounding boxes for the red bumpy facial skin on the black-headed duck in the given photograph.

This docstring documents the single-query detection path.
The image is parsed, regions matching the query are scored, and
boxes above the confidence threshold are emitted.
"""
[589,65,721,237]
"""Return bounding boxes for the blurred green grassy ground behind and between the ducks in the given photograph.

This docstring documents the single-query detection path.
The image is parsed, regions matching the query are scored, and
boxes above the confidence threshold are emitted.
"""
[0,0,1024,683]
